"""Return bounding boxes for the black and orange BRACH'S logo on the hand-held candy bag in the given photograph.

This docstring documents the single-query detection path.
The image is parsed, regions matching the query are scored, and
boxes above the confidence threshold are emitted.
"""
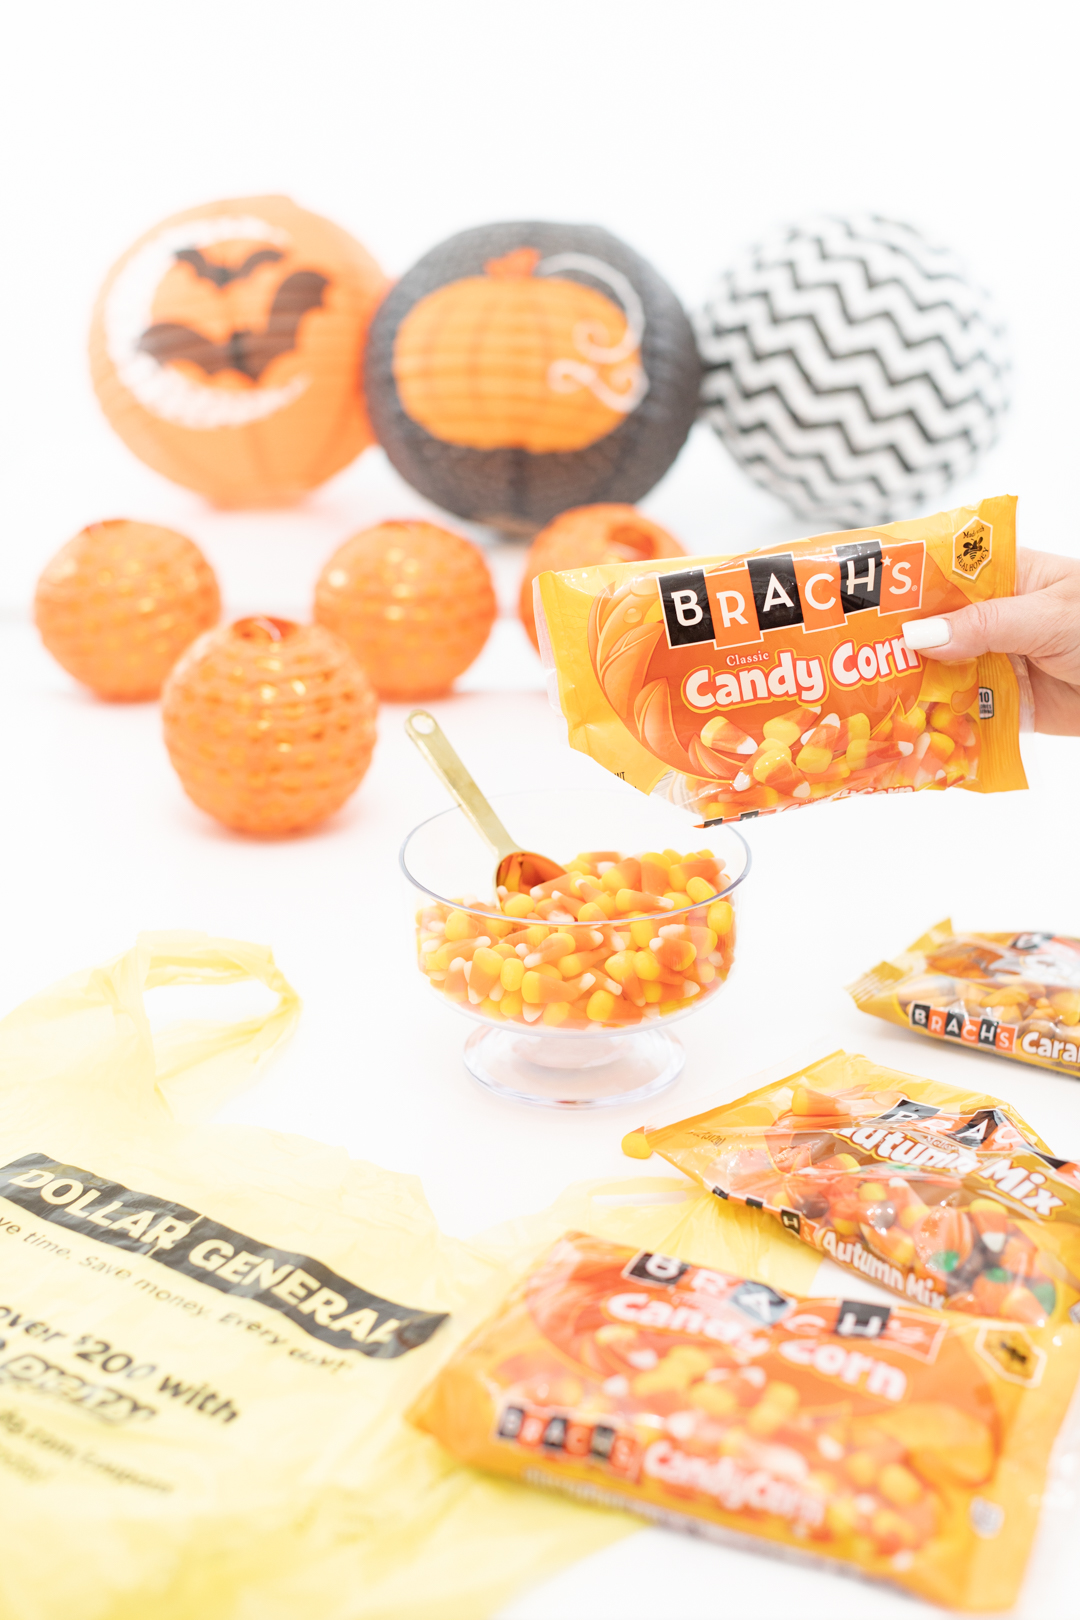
[657,539,926,651]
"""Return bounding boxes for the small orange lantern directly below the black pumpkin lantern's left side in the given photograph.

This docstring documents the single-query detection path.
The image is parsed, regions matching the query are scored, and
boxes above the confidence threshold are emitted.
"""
[314,522,495,700]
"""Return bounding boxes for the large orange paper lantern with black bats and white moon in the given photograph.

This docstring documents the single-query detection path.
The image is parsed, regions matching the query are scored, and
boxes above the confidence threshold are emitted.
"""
[91,196,389,507]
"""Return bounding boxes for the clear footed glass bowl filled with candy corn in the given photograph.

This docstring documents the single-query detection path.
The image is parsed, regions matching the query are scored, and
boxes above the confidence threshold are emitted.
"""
[402,789,750,1108]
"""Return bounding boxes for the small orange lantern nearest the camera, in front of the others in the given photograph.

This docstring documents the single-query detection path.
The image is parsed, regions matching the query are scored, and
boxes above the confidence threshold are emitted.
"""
[164,619,377,836]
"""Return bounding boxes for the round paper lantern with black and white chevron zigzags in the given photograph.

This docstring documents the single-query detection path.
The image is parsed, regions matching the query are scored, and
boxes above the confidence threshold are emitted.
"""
[696,214,1009,527]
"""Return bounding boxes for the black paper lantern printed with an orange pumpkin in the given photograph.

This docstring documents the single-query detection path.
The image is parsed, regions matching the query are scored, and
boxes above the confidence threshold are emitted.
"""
[364,222,701,535]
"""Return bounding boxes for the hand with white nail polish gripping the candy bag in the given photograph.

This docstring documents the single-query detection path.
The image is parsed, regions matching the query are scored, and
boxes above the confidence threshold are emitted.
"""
[904,551,1080,737]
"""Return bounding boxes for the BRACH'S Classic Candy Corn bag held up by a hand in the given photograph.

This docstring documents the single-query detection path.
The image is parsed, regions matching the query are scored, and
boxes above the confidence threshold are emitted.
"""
[536,496,1027,825]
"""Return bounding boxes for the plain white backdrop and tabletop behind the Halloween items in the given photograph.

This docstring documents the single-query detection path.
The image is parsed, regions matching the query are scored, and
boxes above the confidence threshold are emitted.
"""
[0,0,1080,1620]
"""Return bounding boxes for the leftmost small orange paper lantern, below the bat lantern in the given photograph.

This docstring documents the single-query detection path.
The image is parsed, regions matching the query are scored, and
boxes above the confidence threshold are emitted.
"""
[34,518,222,701]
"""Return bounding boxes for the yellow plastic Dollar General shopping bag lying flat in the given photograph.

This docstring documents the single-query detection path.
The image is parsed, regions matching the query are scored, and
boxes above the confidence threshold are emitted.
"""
[0,933,818,1620]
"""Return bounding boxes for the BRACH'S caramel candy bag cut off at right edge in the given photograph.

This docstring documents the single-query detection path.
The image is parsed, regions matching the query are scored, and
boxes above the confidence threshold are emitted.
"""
[847,919,1080,1079]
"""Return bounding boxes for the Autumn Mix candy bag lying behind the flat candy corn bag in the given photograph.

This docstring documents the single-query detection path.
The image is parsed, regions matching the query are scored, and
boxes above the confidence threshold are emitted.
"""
[644,1051,1080,1327]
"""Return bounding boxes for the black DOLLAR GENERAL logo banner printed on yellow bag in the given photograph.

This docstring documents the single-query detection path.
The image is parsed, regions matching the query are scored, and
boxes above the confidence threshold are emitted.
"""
[0,1153,445,1358]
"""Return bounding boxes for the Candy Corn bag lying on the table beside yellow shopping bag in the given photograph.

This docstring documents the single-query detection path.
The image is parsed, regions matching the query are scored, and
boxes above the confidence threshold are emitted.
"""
[410,1233,1080,1610]
